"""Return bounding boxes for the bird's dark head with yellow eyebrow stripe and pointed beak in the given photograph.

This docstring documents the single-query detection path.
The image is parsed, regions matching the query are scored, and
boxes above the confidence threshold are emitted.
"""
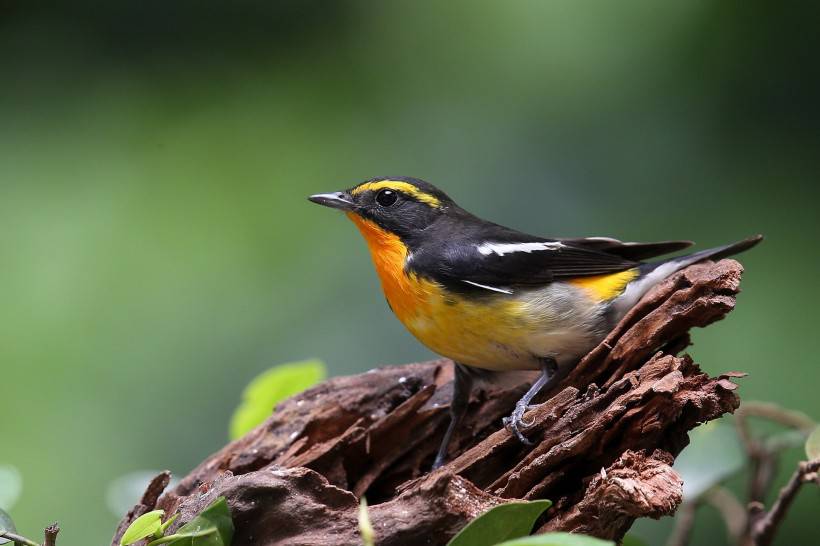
[308,177,455,240]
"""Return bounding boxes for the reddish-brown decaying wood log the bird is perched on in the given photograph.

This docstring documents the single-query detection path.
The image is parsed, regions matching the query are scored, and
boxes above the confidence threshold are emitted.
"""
[114,260,742,546]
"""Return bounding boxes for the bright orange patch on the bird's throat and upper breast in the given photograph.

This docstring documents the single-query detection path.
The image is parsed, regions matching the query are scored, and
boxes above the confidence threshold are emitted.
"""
[347,212,428,322]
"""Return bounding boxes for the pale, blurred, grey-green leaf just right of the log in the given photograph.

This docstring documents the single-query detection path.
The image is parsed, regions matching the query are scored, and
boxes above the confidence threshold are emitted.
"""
[675,420,746,501]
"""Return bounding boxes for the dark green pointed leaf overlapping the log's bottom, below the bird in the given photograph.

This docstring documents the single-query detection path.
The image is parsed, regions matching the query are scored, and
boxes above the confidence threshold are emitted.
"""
[447,500,552,546]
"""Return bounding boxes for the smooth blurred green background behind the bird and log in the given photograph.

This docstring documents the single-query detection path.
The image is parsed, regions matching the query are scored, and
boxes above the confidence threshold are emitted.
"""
[0,0,820,546]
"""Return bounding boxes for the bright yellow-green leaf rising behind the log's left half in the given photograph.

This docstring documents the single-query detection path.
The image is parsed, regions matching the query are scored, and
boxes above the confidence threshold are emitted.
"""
[230,360,326,440]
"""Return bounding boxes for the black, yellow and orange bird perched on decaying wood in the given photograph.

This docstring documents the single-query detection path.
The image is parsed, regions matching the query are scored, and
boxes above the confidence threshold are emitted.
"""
[308,176,763,469]
